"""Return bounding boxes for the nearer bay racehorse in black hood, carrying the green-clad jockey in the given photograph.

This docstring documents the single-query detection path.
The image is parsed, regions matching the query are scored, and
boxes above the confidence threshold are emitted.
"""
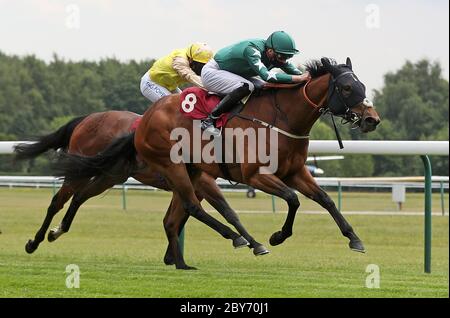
[52,58,380,264]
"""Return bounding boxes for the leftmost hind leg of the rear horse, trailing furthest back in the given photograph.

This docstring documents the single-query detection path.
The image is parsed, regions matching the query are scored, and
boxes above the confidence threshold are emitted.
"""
[25,182,83,254]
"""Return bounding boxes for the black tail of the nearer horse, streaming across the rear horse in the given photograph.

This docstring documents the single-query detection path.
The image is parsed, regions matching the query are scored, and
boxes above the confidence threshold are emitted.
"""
[52,132,138,181]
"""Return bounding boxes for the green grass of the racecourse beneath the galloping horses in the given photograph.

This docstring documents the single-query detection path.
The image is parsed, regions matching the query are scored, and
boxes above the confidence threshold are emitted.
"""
[0,188,449,297]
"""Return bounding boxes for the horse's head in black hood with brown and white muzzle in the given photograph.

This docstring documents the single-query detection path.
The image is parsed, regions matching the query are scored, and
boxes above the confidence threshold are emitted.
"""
[321,58,380,133]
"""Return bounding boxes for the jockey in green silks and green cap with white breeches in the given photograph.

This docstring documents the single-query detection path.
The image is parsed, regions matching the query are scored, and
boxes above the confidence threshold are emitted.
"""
[201,31,309,136]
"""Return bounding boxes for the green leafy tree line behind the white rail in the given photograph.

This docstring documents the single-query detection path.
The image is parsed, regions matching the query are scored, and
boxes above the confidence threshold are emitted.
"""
[0,52,449,176]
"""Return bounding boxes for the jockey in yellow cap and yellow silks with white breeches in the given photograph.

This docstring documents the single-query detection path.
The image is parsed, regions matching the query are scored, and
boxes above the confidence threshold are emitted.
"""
[141,43,213,103]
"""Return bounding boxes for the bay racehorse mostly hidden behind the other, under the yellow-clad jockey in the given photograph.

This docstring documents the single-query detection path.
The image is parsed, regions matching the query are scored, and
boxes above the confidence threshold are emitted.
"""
[15,111,268,269]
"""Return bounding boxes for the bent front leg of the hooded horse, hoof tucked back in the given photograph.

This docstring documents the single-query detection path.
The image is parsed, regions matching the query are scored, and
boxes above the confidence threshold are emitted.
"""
[248,174,300,246]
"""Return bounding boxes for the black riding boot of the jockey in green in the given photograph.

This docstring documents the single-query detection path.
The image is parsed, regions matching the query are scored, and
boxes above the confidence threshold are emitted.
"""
[201,83,251,136]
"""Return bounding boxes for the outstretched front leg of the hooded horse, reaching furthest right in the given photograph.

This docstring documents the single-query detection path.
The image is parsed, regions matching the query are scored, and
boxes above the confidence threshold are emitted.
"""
[287,166,365,253]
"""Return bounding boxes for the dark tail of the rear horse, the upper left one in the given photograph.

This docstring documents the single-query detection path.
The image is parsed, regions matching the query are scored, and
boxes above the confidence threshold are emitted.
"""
[14,116,87,160]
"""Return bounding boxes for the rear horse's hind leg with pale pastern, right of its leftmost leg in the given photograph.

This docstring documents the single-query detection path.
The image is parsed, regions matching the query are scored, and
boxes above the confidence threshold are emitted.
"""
[48,176,119,242]
